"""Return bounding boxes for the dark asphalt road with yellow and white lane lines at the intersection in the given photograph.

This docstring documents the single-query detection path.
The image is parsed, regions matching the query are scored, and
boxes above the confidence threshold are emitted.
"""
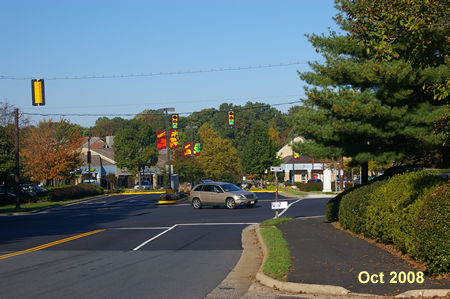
[0,193,327,298]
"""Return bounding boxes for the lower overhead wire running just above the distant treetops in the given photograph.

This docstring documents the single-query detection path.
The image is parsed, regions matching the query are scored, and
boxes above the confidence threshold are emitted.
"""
[22,100,300,117]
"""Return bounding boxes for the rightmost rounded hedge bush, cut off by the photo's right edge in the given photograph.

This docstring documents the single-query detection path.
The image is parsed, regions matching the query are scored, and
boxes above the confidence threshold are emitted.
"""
[414,182,450,275]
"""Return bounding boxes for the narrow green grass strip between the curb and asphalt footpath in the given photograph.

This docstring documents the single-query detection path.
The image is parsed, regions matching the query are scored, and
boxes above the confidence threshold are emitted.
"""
[260,227,291,281]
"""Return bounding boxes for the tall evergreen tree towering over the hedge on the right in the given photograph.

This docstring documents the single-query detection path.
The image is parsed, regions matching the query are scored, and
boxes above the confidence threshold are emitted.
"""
[294,0,449,183]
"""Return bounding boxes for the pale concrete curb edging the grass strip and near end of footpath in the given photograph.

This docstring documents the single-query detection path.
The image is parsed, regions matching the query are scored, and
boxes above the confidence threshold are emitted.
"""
[255,225,450,298]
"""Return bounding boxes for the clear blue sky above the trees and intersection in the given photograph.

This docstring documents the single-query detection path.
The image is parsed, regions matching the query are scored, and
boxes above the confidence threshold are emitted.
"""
[0,0,336,126]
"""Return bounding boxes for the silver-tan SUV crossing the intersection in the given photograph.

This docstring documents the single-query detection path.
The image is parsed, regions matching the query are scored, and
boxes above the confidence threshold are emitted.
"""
[189,182,258,209]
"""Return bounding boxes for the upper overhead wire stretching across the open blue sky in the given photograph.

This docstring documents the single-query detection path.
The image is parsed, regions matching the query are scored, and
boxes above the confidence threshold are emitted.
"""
[0,61,308,80]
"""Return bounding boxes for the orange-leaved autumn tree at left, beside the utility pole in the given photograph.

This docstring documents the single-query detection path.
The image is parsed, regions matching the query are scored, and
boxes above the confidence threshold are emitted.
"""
[20,120,82,181]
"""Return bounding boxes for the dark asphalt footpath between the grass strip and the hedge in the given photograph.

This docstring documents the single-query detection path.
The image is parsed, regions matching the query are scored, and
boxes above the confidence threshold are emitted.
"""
[278,217,450,296]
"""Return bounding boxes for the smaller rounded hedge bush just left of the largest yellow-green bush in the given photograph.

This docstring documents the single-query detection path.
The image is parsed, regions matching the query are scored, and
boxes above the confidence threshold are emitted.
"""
[339,181,386,234]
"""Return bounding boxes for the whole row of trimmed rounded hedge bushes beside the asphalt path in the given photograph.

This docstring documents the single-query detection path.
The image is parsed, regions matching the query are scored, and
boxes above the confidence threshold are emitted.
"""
[338,171,450,275]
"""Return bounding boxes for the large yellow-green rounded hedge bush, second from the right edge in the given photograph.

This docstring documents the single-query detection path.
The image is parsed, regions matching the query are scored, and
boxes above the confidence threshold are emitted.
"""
[366,171,445,252]
